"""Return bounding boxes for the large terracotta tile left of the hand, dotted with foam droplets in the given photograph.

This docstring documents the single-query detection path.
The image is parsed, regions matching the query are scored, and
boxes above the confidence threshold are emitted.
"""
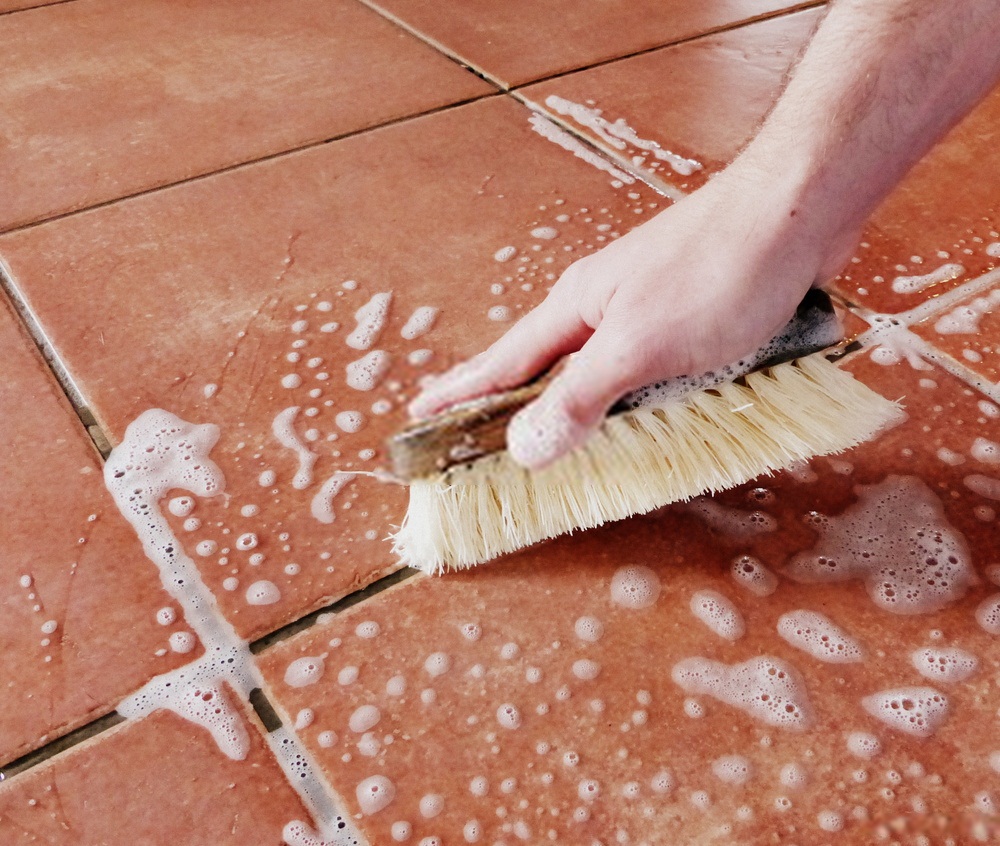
[0,99,664,638]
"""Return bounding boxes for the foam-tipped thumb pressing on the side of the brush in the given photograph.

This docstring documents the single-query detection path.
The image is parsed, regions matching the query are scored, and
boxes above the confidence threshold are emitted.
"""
[507,320,647,470]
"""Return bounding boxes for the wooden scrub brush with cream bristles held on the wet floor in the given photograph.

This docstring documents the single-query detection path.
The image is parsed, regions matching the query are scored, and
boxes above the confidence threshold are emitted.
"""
[388,289,903,573]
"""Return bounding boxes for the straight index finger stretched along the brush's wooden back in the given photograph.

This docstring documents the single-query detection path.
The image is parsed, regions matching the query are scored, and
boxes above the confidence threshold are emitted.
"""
[409,294,591,418]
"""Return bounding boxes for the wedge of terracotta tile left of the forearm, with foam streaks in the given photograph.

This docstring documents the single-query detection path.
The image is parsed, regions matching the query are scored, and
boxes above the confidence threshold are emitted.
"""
[521,9,823,189]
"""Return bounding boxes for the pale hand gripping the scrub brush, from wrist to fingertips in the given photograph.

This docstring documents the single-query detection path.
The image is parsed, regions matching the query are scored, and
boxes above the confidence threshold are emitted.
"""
[410,161,856,468]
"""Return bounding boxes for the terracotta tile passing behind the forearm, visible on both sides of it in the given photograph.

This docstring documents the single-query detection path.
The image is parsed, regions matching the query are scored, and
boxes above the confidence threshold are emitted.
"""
[524,10,1000,313]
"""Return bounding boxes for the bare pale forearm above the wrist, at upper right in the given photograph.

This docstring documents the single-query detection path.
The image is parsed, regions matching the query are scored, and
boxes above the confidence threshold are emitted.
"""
[737,0,1000,242]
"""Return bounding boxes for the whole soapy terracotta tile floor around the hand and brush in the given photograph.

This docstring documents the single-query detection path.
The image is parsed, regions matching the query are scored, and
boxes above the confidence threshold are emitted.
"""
[0,0,1000,846]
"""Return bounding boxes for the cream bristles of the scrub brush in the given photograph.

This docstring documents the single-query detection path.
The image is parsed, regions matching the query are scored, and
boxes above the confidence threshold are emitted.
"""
[393,354,902,573]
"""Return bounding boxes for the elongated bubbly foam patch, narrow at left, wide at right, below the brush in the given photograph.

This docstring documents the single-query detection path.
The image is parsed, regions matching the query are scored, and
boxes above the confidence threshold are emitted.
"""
[671,656,812,730]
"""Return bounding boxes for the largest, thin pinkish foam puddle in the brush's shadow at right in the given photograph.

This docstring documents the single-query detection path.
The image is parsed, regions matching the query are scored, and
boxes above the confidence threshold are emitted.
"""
[786,476,977,614]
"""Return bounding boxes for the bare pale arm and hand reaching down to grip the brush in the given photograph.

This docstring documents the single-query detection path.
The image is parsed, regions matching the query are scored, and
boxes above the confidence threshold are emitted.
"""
[410,0,1000,469]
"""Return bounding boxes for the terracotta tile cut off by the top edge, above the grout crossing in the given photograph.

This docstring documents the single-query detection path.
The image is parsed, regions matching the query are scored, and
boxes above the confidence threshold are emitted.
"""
[366,0,820,86]
